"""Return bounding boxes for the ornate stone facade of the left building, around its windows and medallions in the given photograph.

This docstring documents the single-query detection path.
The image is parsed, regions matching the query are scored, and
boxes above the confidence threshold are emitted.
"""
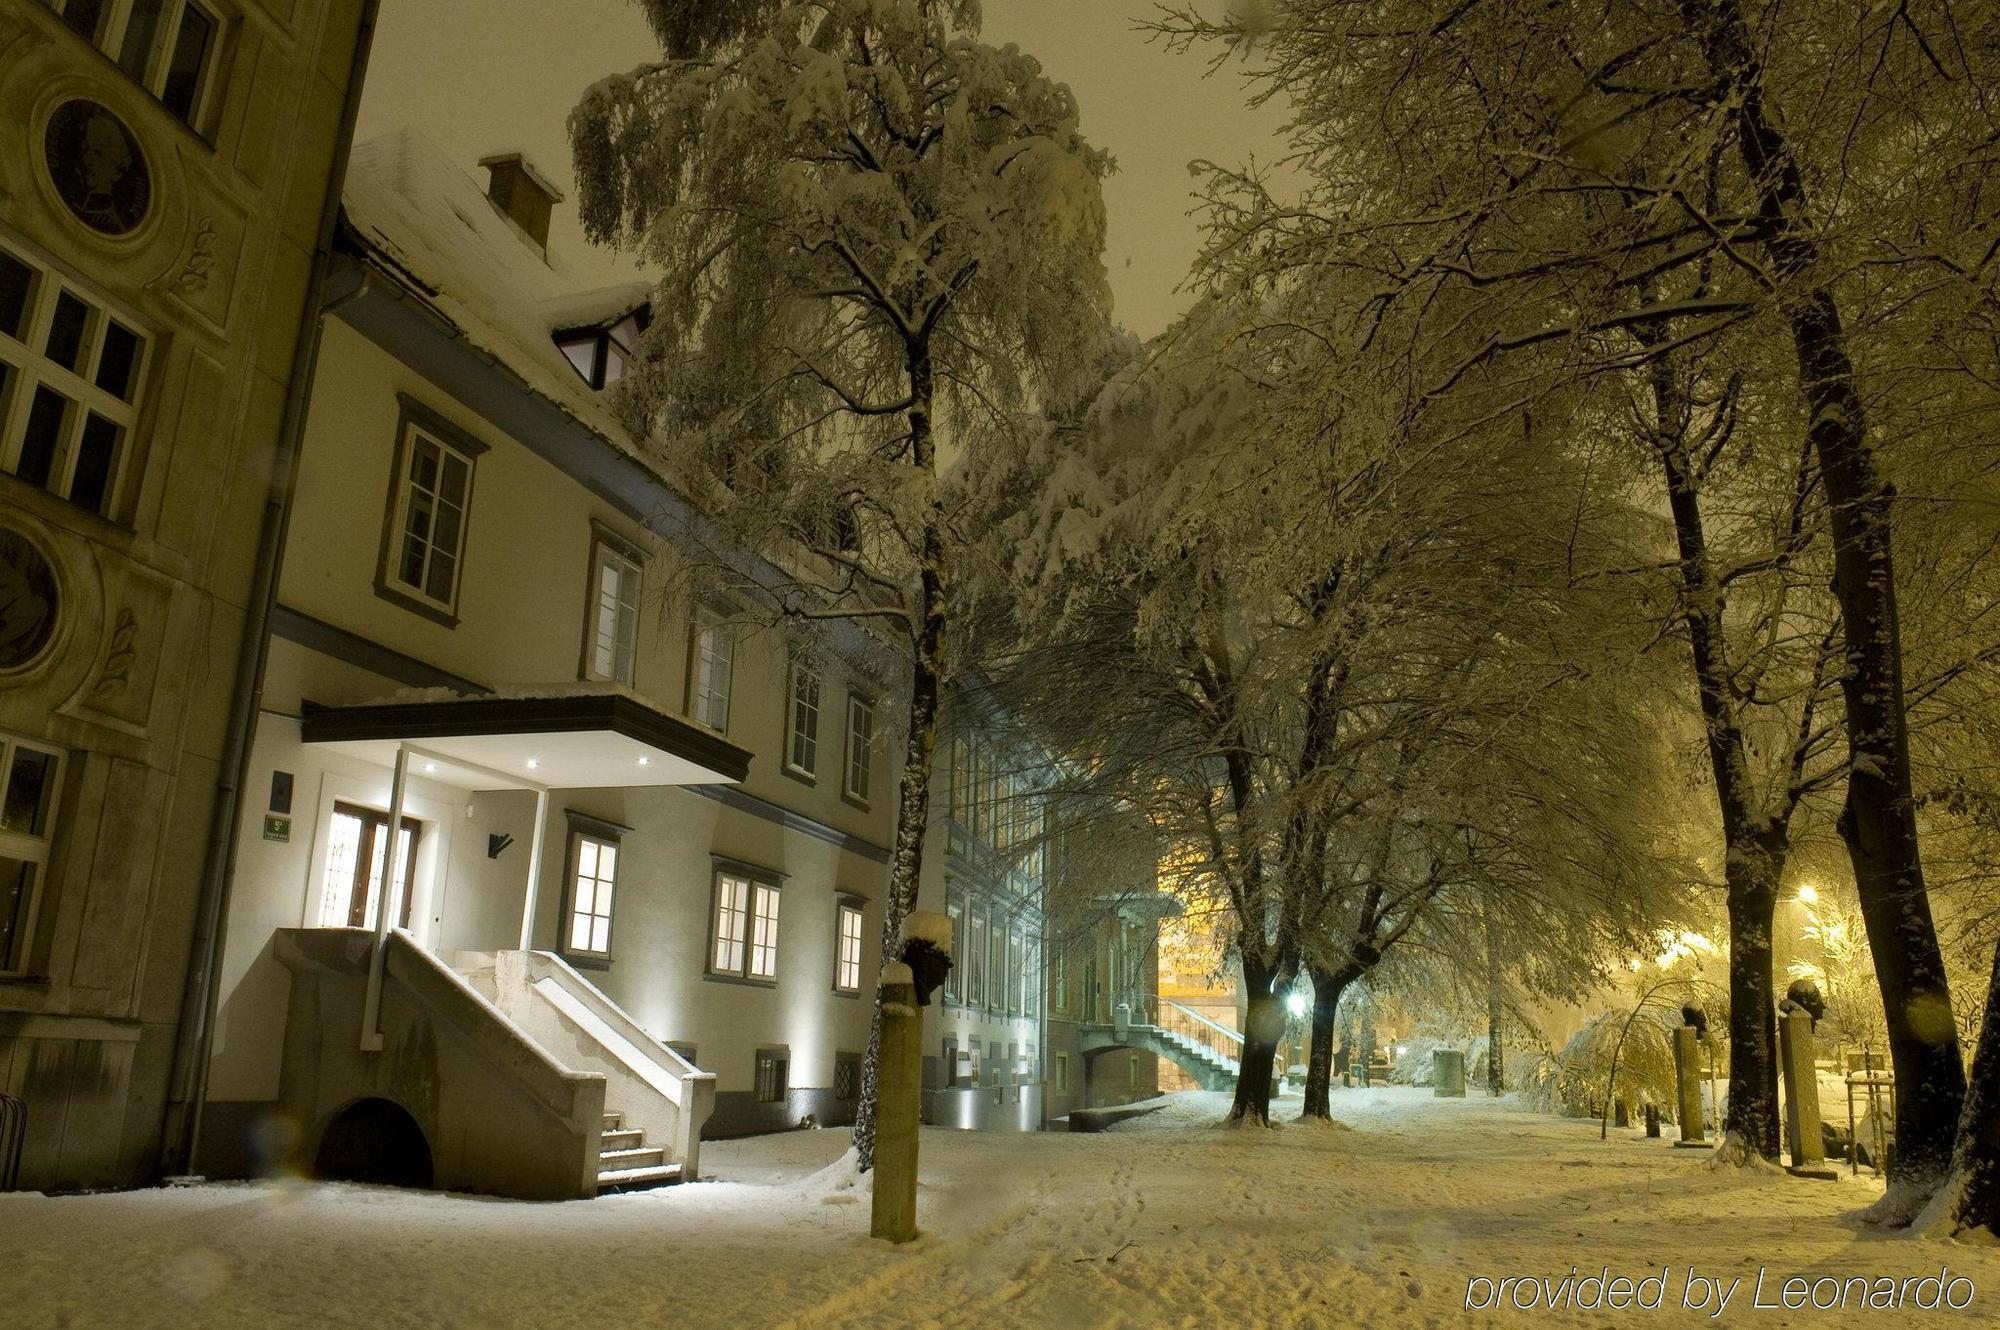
[0,0,364,1188]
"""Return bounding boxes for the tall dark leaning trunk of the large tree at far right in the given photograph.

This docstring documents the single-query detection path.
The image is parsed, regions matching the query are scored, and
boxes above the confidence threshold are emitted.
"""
[1682,0,1966,1196]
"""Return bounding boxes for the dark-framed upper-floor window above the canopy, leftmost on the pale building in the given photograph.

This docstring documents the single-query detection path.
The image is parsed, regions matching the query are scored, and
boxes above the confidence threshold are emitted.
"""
[376,396,486,626]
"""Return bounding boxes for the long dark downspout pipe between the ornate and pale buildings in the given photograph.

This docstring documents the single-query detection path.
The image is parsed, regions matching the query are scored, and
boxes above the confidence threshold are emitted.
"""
[160,0,380,1178]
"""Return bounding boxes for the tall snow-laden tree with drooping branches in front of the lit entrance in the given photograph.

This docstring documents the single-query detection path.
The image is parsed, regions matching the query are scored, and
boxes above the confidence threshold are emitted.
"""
[570,0,1110,1168]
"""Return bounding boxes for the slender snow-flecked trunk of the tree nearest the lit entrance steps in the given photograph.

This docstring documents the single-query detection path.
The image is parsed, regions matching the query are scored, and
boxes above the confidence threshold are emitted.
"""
[854,348,946,1172]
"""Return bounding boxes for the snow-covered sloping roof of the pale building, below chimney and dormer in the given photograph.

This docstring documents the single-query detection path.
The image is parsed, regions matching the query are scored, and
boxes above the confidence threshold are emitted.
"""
[342,130,644,466]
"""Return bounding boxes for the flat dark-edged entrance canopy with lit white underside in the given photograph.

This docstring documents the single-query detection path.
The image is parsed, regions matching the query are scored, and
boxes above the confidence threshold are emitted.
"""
[300,688,750,790]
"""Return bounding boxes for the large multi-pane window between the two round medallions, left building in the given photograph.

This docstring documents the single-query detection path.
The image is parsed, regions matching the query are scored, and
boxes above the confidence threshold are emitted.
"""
[0,246,150,516]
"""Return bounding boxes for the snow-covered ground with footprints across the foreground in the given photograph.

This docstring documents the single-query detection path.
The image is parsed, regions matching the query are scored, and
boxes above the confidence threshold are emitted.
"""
[0,1088,2000,1328]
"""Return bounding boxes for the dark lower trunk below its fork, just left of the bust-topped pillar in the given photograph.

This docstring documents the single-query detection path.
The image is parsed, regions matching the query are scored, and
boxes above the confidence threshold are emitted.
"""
[1722,828,1786,1160]
